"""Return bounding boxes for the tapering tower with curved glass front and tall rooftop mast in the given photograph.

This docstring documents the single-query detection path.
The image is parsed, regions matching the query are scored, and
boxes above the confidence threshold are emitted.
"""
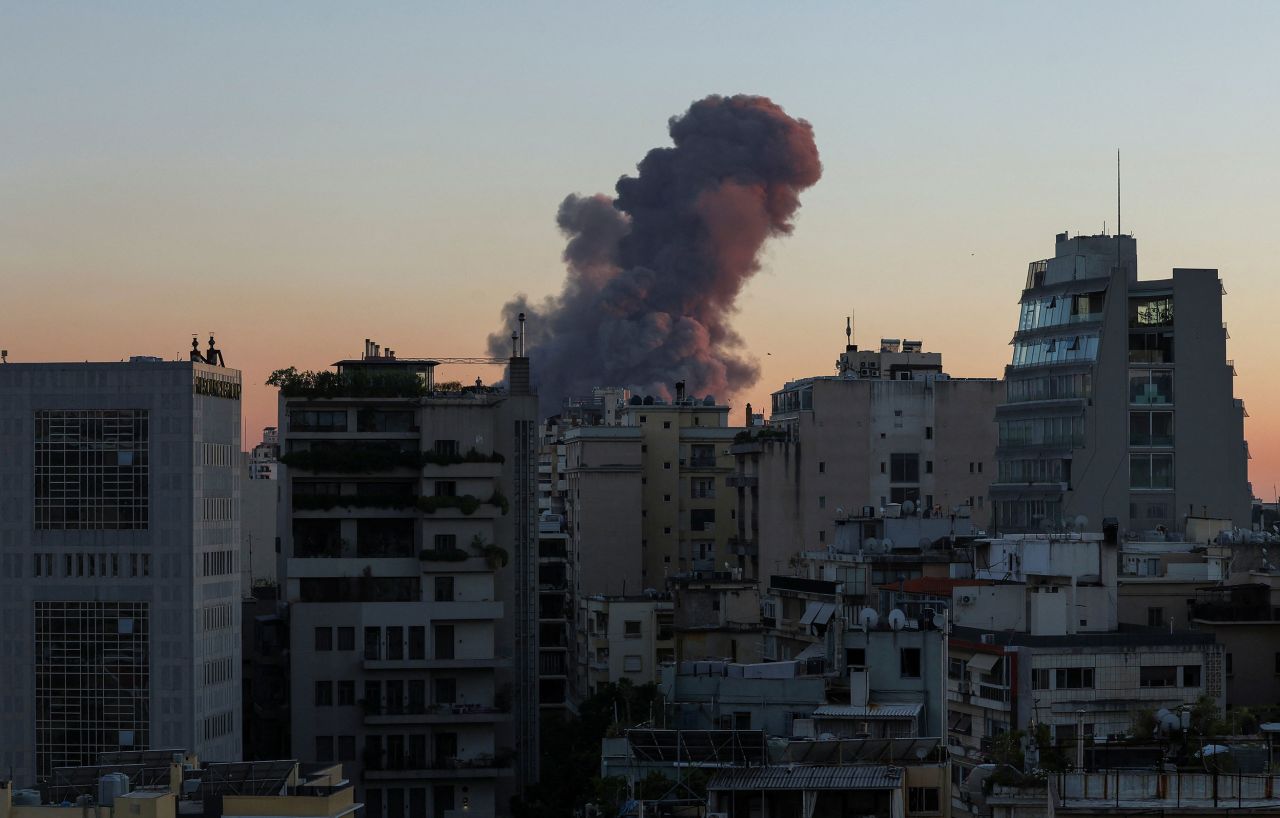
[991,233,1252,531]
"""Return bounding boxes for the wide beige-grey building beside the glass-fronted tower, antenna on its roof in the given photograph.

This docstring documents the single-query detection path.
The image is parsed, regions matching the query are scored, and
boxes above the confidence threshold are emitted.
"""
[730,328,1002,577]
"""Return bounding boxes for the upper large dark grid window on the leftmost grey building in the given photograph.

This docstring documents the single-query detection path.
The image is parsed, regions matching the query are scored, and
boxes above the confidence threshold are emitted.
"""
[35,410,150,530]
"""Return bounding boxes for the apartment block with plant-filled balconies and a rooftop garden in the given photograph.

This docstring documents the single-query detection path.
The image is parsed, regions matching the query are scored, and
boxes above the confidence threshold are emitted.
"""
[279,344,539,818]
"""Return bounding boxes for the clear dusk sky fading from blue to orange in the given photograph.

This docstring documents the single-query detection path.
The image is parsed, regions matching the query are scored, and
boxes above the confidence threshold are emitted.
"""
[0,0,1280,491]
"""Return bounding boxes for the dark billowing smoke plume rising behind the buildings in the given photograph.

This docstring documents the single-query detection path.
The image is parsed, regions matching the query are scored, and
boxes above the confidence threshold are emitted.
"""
[489,96,822,412]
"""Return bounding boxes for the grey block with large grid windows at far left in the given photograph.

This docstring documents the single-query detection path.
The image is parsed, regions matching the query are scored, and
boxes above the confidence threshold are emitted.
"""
[0,347,241,781]
